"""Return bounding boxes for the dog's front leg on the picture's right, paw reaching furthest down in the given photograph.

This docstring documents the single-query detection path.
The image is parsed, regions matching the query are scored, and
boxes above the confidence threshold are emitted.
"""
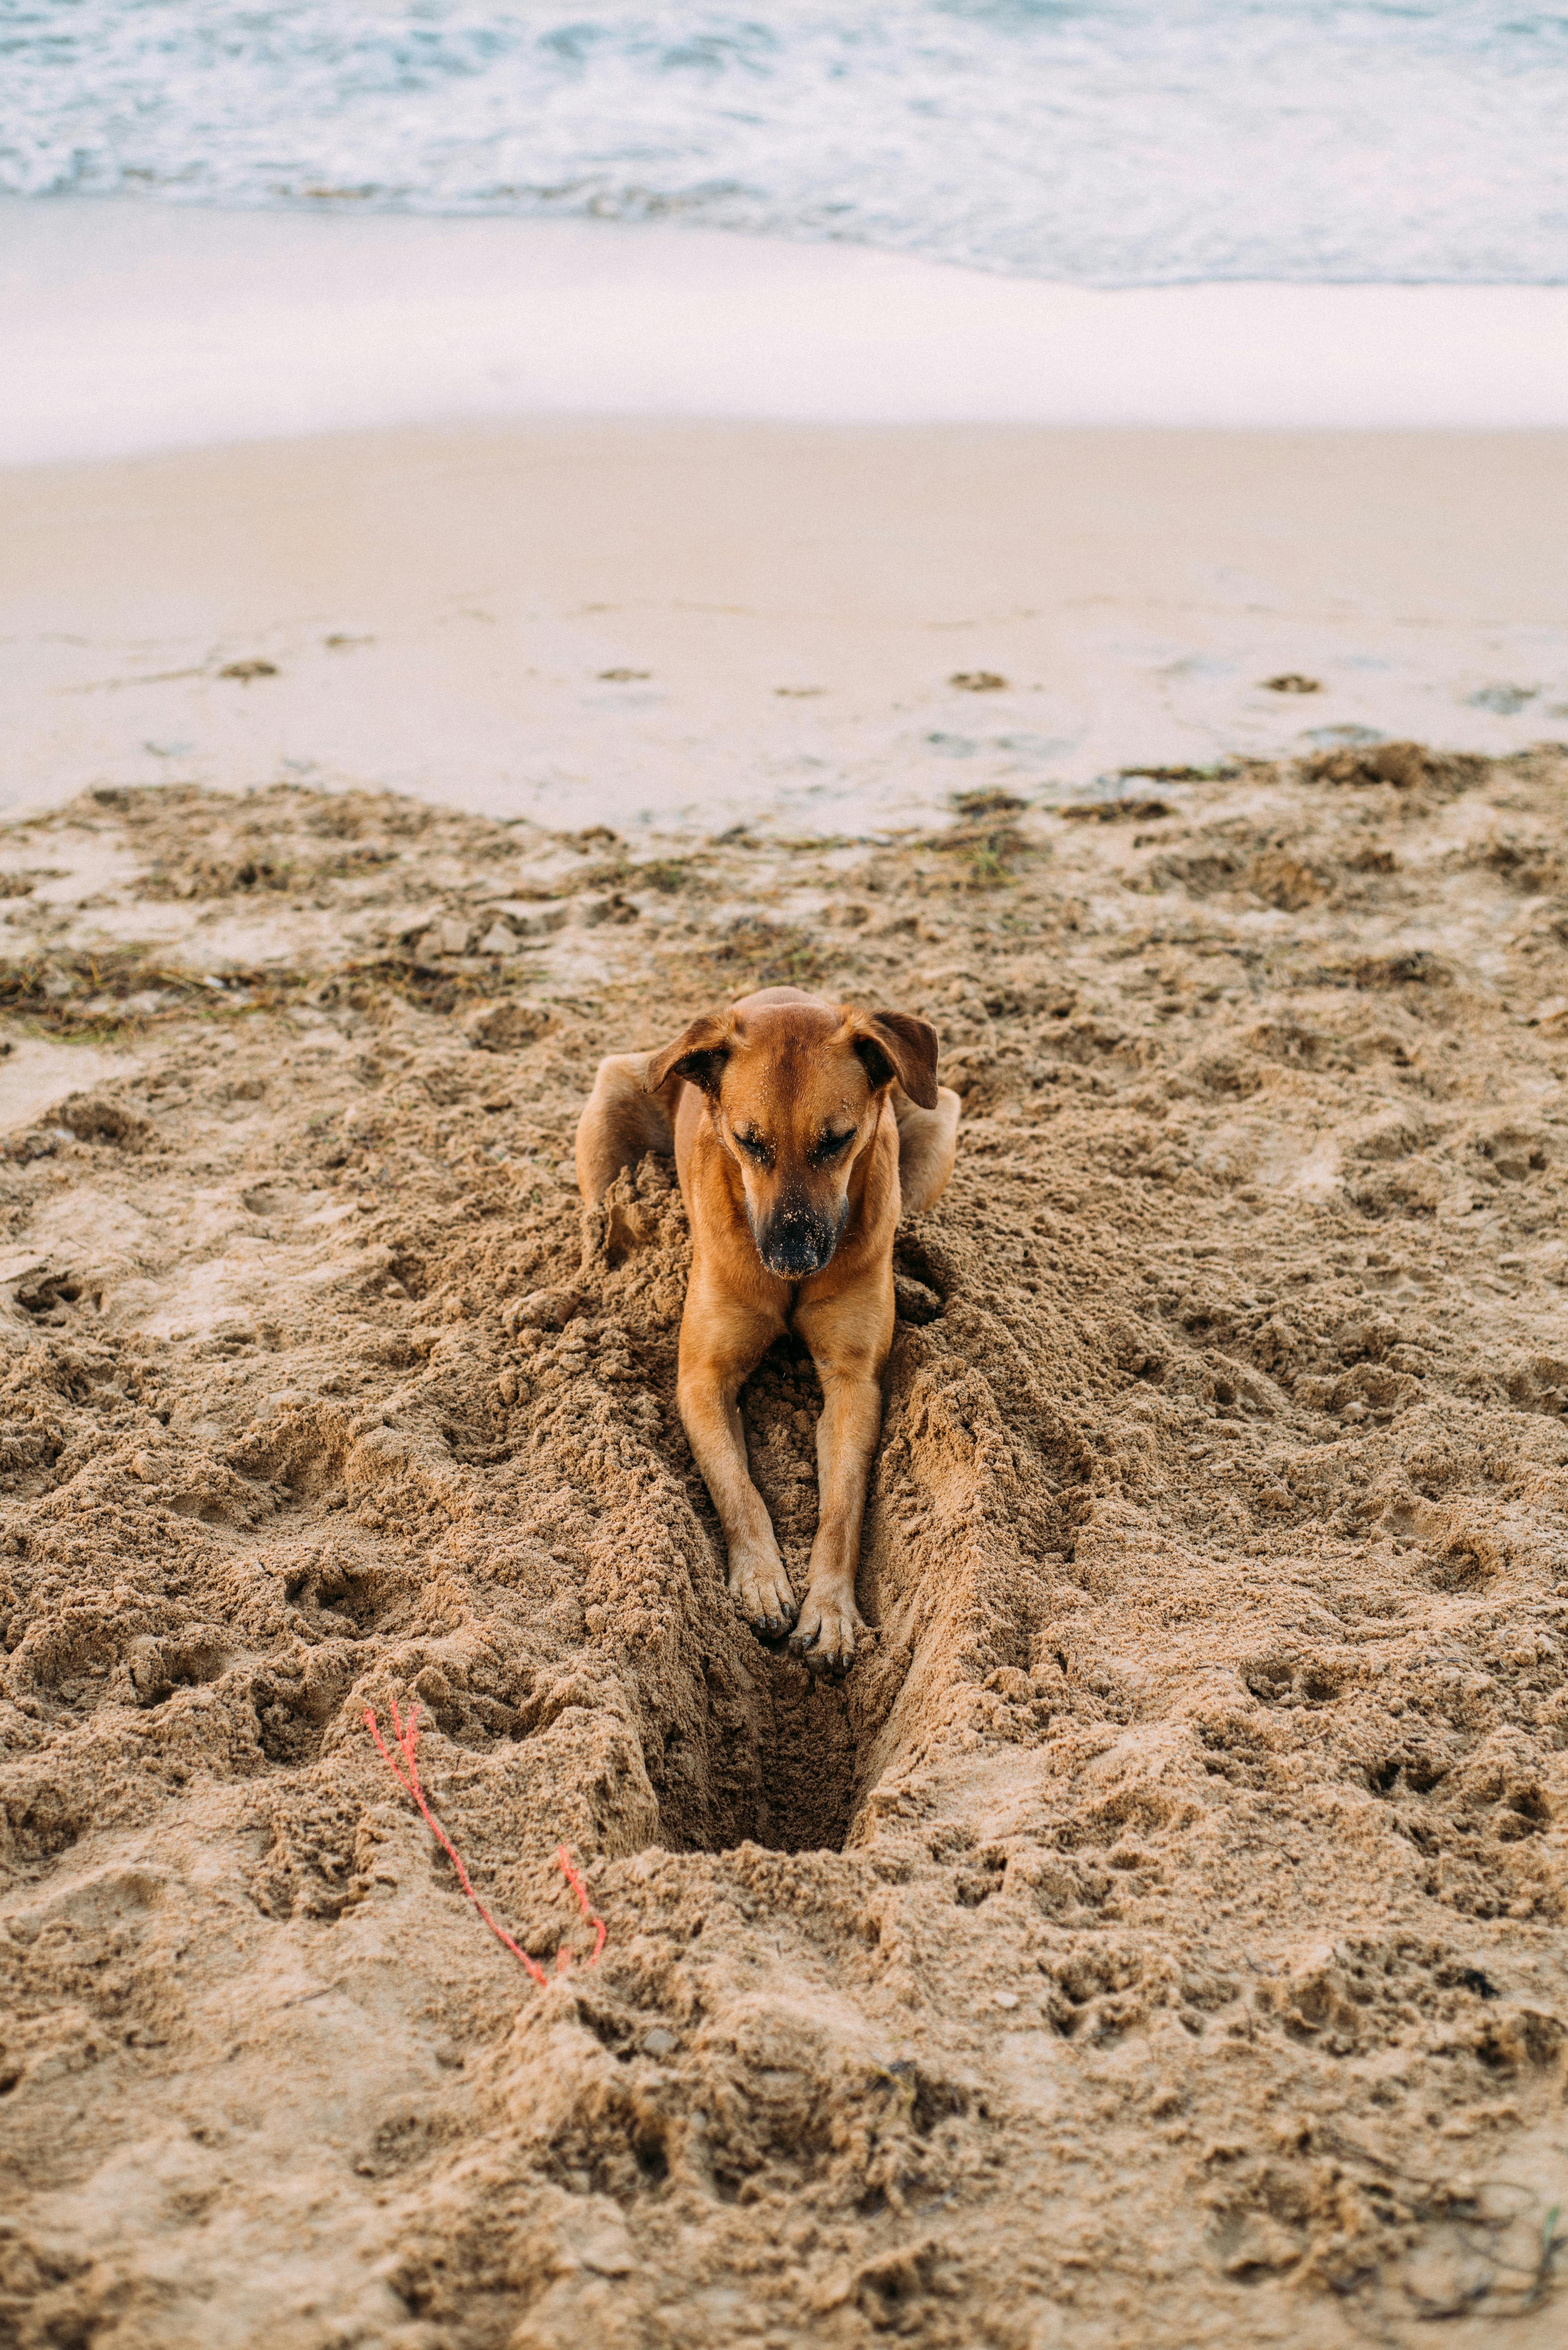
[790,1271,893,1673]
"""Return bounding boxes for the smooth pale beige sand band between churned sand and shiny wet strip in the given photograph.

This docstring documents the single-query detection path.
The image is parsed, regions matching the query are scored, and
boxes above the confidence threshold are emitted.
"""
[0,421,1568,825]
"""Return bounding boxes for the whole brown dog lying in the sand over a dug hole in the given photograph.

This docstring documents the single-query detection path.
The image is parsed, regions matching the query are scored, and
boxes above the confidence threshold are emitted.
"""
[576,987,959,1671]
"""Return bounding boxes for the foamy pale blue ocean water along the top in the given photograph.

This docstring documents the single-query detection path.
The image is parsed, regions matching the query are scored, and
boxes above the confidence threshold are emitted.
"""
[0,0,1568,287]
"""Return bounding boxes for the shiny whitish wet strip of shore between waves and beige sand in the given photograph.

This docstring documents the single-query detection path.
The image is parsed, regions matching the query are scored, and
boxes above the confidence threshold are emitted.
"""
[0,200,1568,465]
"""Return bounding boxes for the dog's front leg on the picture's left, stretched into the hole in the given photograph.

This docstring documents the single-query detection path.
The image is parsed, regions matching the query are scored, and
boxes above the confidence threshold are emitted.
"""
[677,1278,797,1638]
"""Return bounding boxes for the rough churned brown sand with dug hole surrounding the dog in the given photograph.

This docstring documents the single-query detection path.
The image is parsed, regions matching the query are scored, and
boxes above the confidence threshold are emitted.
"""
[0,747,1568,2350]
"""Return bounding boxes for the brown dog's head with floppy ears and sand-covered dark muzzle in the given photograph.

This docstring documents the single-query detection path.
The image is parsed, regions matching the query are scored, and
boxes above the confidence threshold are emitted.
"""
[646,987,936,1281]
